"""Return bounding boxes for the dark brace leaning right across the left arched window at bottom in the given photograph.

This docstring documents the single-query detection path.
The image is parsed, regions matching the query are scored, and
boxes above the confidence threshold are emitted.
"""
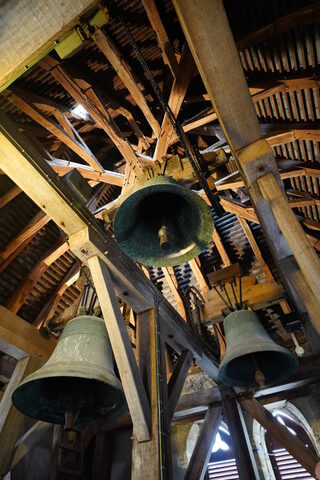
[184,407,222,480]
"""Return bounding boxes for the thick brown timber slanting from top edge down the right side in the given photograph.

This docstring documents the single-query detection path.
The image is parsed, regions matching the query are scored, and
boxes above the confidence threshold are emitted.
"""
[174,0,320,333]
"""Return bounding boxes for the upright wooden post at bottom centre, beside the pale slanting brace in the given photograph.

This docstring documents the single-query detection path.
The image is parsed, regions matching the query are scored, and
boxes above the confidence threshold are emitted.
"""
[131,310,171,480]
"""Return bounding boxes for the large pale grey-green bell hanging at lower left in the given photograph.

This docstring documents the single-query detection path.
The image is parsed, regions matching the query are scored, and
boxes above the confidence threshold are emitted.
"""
[12,316,127,428]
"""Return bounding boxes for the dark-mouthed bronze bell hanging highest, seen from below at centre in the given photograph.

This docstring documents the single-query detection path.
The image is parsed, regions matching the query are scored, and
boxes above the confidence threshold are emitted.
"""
[114,175,214,267]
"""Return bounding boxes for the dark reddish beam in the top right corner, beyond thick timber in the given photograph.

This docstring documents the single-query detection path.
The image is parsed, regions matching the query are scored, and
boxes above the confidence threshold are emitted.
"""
[236,2,320,50]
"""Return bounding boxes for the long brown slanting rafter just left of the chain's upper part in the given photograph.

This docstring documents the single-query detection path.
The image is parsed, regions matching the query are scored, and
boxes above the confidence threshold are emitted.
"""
[92,30,160,138]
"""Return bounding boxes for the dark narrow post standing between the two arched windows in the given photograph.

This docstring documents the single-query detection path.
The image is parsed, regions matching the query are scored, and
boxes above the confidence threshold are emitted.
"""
[223,399,260,480]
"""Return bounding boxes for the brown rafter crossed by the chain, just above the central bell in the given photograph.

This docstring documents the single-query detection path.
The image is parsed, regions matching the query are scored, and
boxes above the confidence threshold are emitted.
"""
[153,45,195,161]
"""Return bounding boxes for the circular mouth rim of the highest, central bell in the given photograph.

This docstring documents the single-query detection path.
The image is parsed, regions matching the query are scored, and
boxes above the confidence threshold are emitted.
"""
[113,175,214,267]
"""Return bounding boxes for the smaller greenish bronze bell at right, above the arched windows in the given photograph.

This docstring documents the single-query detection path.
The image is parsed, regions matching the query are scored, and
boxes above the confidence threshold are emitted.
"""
[218,310,298,387]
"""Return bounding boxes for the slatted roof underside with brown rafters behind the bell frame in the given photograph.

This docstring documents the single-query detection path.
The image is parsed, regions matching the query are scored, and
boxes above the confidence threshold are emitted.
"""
[0,0,320,360]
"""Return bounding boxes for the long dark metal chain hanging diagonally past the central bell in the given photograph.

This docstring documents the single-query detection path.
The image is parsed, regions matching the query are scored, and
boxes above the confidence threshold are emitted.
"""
[109,0,223,215]
